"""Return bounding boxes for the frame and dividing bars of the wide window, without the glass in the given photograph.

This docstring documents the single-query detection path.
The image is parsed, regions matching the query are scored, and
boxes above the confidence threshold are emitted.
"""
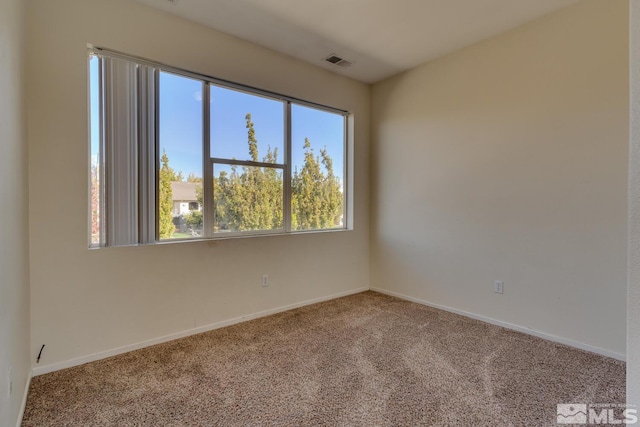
[87,45,353,248]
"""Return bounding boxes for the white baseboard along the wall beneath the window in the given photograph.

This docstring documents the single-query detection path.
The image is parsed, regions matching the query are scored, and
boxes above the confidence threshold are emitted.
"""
[33,286,369,376]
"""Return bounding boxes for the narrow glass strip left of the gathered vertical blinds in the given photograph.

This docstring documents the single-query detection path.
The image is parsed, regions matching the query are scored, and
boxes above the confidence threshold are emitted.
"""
[89,56,102,246]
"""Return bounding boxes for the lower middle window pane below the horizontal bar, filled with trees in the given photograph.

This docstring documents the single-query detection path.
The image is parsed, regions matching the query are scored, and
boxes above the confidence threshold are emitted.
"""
[213,164,284,234]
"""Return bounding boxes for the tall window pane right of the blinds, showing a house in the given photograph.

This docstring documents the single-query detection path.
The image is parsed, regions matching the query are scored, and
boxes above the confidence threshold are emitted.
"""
[158,72,203,239]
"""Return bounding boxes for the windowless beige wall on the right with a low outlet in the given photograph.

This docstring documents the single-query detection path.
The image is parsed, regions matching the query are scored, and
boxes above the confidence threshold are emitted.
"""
[371,0,629,358]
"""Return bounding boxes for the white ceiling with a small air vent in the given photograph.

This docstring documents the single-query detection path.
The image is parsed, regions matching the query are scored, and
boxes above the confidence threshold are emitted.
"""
[131,0,578,83]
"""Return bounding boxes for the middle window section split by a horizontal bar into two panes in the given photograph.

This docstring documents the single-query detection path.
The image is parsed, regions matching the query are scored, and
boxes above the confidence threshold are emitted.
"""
[210,85,287,235]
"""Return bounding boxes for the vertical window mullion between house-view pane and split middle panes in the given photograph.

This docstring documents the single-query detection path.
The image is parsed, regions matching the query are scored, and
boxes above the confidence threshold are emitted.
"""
[202,82,215,237]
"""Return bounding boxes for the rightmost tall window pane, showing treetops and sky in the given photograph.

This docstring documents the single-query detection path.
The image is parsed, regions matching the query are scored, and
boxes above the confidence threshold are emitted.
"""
[291,104,345,231]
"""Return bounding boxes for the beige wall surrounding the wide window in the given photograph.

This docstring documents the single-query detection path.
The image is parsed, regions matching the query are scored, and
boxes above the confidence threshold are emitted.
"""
[27,0,370,373]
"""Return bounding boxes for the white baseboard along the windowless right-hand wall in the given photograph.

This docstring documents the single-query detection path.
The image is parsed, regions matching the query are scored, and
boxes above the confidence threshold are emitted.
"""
[371,288,626,361]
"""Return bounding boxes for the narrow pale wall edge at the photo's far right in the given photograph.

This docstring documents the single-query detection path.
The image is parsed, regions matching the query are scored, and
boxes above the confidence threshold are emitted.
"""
[627,0,640,406]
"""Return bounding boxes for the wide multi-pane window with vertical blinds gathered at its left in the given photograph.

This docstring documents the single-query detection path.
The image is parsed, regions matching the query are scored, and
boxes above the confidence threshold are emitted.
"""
[89,49,347,247]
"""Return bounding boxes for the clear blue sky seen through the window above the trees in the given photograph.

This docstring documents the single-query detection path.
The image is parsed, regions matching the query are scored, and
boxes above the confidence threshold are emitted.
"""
[90,58,344,186]
